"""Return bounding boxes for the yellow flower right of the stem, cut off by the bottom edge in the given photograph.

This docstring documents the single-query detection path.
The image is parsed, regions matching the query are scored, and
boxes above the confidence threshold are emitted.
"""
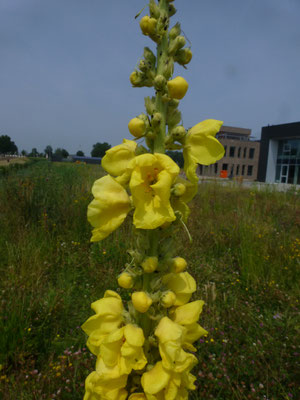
[141,361,196,400]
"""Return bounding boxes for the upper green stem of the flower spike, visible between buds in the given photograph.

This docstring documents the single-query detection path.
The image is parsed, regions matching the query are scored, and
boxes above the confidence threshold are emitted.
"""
[153,0,168,153]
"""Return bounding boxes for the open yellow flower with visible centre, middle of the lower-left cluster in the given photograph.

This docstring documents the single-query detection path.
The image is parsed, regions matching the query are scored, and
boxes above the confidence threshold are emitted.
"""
[99,324,147,375]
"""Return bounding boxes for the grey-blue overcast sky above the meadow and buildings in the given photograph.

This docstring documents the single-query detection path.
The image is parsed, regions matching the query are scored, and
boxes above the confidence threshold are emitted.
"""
[0,0,300,154]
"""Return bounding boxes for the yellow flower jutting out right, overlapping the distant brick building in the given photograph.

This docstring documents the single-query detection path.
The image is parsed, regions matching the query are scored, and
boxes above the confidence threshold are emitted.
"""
[183,119,224,182]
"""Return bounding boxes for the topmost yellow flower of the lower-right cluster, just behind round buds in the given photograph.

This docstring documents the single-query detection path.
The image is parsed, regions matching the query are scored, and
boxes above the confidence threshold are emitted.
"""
[162,272,196,306]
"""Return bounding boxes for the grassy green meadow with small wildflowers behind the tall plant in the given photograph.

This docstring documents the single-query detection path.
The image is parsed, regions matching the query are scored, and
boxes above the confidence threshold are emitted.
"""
[0,161,300,400]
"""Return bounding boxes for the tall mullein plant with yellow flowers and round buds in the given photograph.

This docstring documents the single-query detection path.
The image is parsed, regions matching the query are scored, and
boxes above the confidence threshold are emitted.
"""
[82,0,224,400]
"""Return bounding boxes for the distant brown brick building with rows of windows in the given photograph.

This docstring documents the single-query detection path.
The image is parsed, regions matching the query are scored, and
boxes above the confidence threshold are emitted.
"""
[198,126,260,181]
